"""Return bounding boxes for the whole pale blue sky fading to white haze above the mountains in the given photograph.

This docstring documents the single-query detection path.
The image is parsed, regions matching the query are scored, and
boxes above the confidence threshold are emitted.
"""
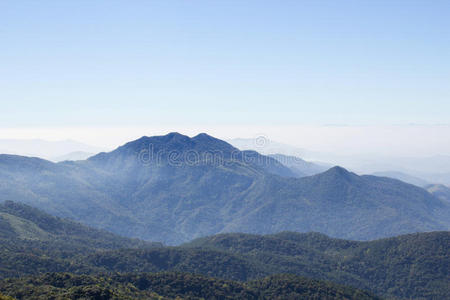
[0,0,450,155]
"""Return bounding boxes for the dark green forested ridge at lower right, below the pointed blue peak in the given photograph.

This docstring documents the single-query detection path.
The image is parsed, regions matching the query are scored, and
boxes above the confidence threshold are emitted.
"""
[185,232,450,299]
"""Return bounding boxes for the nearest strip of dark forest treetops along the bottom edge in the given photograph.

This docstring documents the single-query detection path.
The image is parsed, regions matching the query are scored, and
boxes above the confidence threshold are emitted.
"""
[0,273,379,300]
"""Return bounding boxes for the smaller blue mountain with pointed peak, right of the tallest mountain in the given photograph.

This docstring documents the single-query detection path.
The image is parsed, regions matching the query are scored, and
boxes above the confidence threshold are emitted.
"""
[214,167,448,240]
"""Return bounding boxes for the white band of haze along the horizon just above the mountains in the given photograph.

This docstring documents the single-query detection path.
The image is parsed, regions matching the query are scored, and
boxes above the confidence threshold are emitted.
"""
[0,125,450,157]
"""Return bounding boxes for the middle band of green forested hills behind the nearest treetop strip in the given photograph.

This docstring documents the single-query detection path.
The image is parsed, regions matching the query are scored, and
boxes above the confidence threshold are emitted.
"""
[0,202,450,299]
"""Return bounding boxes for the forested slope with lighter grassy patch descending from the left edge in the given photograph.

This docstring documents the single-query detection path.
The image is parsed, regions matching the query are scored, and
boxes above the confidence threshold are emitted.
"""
[0,201,162,277]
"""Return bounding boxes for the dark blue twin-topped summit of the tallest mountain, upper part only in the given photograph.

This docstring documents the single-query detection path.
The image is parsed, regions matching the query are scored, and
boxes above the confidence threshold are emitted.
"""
[89,132,294,177]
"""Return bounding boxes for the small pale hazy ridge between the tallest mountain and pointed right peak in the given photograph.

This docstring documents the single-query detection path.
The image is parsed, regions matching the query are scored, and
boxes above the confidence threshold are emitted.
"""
[269,154,331,177]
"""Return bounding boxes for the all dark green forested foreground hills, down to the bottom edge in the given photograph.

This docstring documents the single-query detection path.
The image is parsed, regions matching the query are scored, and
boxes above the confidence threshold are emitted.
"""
[0,202,450,299]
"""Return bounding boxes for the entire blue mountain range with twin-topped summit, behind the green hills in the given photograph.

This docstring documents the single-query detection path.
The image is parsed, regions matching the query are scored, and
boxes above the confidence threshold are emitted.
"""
[0,133,450,244]
